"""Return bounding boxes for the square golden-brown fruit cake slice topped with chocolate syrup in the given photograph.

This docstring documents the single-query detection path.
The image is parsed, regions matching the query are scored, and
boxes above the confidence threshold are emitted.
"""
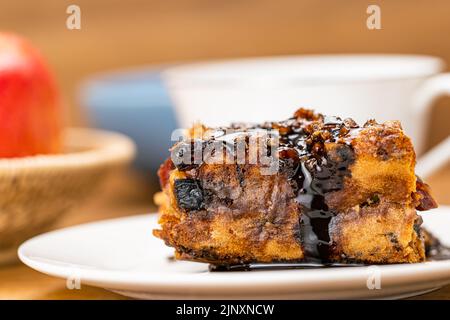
[153,109,436,265]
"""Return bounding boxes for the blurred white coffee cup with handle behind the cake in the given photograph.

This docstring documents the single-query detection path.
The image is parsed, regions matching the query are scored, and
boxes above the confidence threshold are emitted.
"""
[163,55,450,176]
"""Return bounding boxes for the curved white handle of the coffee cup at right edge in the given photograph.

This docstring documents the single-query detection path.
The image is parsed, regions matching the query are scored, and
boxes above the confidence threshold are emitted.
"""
[412,73,450,178]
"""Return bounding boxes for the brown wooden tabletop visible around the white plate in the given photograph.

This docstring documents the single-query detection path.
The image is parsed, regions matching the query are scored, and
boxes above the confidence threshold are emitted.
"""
[0,168,450,300]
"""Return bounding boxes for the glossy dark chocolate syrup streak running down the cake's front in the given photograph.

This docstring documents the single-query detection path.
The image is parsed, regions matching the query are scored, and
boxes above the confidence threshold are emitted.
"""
[273,109,359,265]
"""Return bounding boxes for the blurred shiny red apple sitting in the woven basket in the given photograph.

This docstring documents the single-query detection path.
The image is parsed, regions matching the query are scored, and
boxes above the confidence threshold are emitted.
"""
[0,33,62,158]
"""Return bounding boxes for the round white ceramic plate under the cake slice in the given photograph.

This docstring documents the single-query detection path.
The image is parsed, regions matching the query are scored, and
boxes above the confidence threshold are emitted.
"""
[19,207,450,299]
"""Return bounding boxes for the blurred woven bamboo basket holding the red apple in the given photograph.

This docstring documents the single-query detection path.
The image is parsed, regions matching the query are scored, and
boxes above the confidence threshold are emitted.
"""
[0,128,135,264]
